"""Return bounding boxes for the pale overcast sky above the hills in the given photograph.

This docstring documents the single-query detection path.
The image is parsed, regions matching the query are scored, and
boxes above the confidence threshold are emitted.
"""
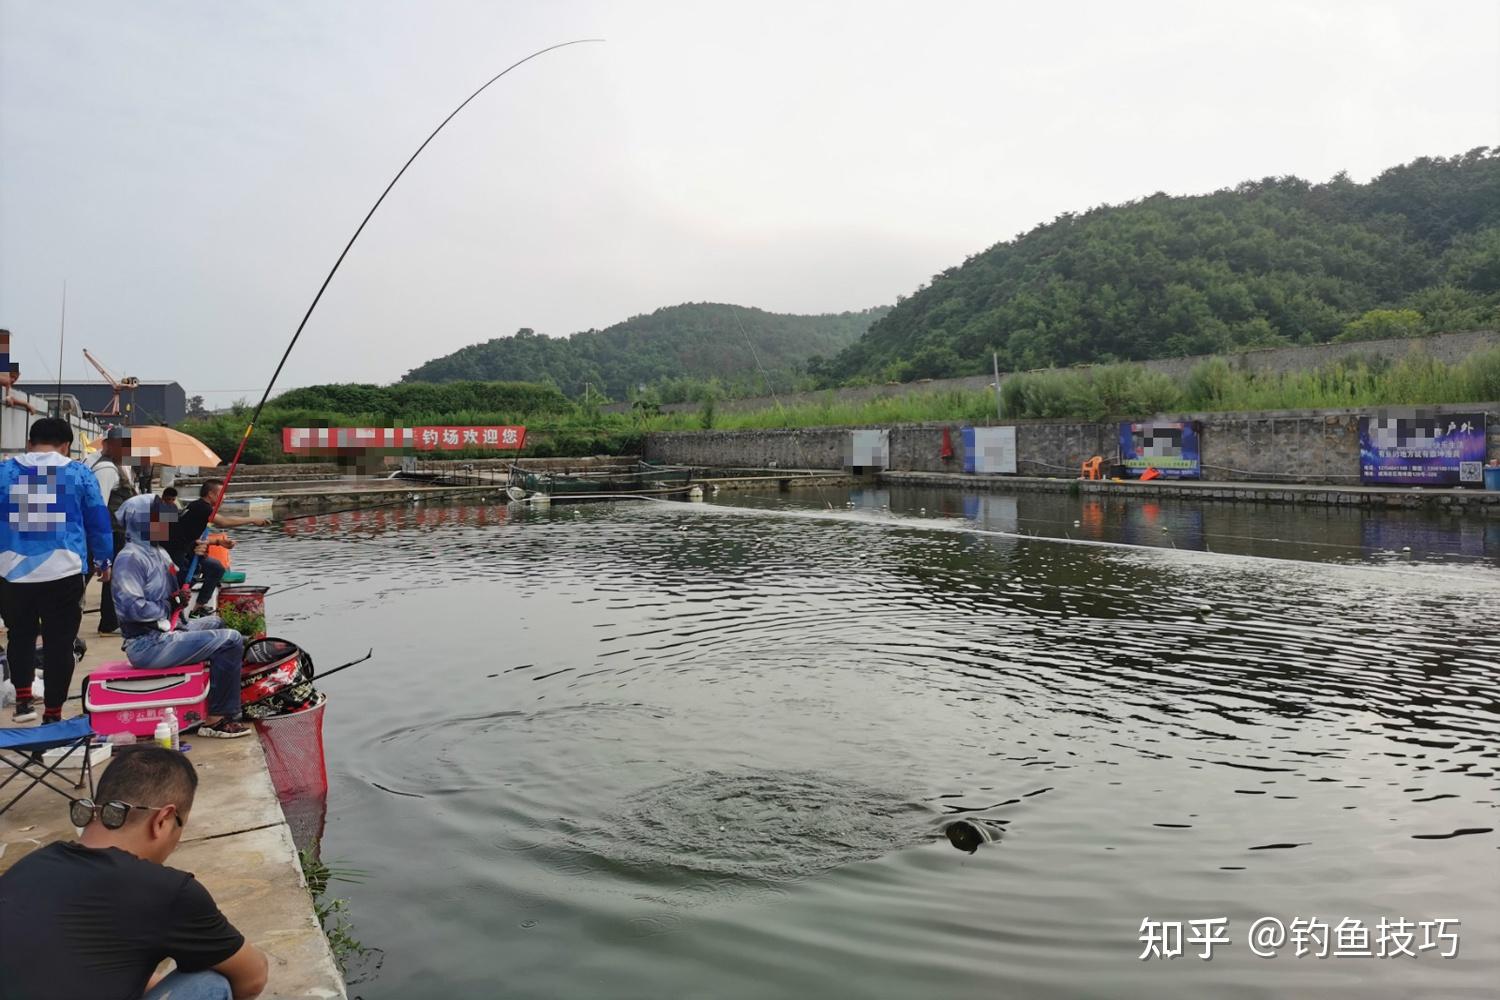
[0,0,1500,406]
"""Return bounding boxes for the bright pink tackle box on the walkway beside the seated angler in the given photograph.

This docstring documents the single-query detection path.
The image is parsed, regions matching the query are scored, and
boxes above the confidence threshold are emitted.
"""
[84,660,209,739]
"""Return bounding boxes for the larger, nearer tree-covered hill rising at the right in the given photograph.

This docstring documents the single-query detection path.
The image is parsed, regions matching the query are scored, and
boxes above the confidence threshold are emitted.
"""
[815,147,1500,382]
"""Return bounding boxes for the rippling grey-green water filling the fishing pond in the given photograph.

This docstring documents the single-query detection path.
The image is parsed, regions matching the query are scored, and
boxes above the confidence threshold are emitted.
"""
[236,490,1500,999]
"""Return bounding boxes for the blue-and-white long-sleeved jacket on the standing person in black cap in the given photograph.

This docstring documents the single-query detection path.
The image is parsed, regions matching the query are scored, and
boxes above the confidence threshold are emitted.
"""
[0,451,114,583]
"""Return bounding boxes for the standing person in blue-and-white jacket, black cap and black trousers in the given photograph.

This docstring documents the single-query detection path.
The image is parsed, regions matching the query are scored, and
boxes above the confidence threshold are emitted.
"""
[0,417,114,723]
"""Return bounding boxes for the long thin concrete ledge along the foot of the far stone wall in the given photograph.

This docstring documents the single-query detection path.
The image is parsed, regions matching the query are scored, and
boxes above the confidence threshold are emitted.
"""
[876,472,1500,517]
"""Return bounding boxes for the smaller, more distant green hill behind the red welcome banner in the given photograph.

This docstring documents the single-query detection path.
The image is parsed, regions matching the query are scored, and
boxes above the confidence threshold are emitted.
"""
[402,303,887,399]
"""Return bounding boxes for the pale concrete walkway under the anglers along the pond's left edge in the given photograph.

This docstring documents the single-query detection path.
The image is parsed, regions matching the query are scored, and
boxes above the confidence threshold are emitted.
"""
[0,583,347,999]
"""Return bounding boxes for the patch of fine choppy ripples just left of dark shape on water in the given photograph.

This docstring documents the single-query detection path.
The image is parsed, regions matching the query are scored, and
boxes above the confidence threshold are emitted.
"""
[575,771,933,882]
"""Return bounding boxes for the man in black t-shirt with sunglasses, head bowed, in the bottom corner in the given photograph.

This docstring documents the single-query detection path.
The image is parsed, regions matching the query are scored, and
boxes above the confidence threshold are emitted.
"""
[0,745,267,1000]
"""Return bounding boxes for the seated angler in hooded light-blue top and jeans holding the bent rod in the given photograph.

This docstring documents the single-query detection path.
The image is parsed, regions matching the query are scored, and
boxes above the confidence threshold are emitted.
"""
[111,496,251,739]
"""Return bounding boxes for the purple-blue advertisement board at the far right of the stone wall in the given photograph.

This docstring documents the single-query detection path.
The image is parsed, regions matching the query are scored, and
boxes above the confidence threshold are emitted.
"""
[1359,409,1485,486]
